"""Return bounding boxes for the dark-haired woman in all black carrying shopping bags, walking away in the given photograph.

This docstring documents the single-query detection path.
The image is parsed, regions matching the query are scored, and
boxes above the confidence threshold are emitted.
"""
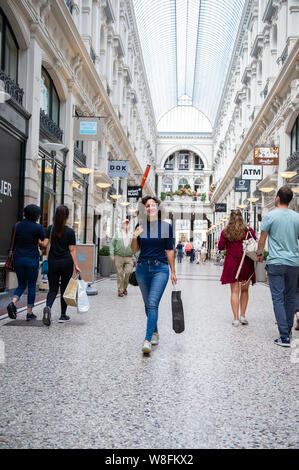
[43,205,80,326]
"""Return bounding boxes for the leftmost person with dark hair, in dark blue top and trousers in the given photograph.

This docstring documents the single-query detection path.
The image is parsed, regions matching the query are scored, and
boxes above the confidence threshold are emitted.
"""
[7,204,45,320]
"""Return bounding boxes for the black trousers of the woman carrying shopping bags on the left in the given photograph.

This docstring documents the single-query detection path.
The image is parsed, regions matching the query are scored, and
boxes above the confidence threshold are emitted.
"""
[47,259,74,315]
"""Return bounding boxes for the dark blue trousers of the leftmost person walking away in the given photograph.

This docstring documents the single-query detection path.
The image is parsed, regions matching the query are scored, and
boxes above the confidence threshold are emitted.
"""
[13,258,39,308]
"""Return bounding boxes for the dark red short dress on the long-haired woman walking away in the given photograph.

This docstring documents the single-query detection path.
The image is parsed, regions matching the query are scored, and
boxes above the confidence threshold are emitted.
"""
[218,227,256,284]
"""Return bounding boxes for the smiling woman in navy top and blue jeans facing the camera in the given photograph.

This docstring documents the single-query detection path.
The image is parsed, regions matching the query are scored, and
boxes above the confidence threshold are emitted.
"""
[131,196,177,353]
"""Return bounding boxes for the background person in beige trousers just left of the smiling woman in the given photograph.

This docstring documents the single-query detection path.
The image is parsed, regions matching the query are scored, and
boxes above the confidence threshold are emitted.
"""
[110,219,133,297]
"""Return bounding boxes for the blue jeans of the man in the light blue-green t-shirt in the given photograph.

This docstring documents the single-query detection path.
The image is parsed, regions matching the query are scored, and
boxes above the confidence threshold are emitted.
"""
[266,264,299,339]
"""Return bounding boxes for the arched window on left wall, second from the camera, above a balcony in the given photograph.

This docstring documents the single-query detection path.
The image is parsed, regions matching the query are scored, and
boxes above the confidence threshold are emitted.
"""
[40,67,60,126]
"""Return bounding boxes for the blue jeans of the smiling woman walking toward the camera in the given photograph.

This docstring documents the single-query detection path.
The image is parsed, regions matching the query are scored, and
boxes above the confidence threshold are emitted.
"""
[136,260,169,341]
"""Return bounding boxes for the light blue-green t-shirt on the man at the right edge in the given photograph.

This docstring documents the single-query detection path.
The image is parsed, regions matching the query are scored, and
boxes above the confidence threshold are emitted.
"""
[261,209,299,266]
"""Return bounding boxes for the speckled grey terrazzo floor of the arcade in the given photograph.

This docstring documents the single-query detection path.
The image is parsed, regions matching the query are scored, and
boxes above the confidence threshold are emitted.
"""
[0,260,299,449]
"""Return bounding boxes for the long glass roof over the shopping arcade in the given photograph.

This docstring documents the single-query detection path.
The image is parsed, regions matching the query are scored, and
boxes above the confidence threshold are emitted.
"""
[133,0,245,132]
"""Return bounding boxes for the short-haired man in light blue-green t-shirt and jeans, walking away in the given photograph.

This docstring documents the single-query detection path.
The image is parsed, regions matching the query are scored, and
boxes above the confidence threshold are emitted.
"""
[257,186,299,347]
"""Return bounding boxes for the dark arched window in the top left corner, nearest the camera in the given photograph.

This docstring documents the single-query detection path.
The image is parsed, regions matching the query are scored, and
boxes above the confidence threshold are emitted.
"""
[0,9,19,83]
